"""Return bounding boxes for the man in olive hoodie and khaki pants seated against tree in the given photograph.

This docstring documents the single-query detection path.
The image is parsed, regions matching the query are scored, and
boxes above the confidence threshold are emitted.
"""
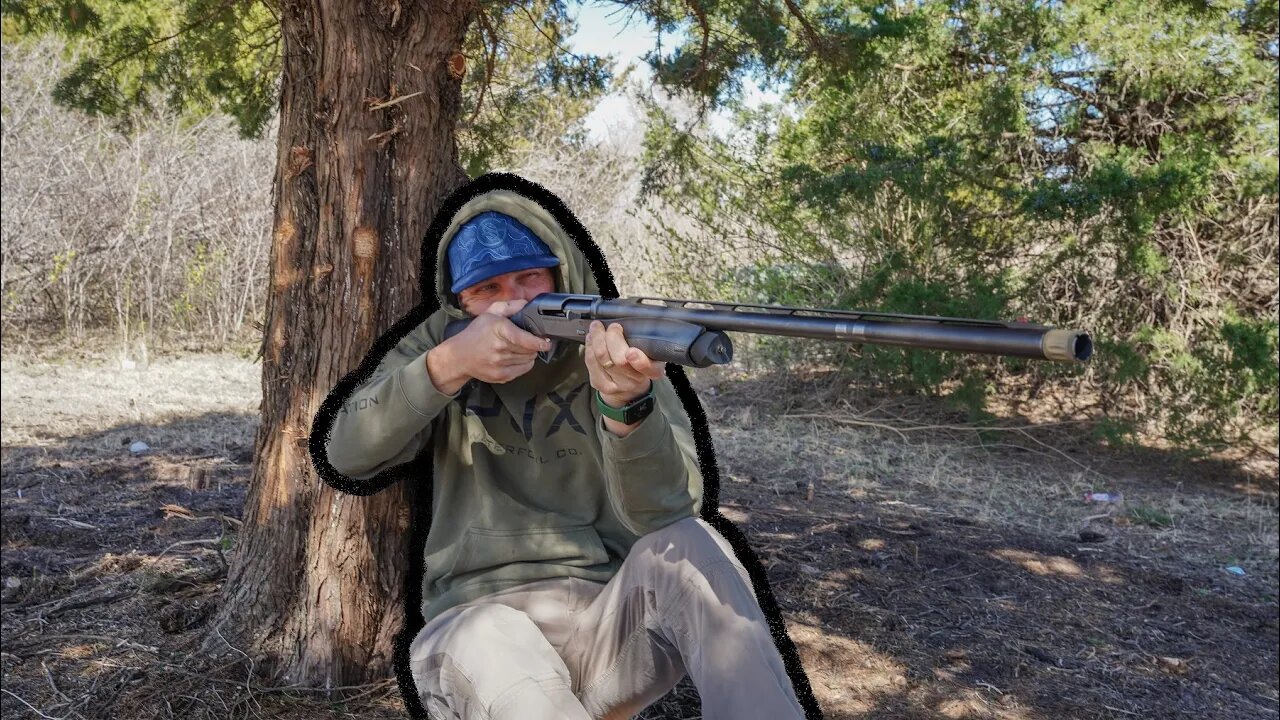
[326,179,804,720]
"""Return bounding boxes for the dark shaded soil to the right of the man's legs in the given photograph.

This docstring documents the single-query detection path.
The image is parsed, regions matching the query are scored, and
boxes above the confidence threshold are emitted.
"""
[740,491,1277,720]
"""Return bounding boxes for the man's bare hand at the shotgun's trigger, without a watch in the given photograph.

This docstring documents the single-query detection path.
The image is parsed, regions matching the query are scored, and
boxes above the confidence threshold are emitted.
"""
[426,300,552,395]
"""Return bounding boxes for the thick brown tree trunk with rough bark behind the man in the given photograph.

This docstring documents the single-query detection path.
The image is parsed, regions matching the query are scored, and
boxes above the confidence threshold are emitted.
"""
[206,0,475,687]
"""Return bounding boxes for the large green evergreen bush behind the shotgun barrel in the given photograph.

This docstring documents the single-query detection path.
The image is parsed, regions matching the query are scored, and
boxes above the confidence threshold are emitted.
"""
[645,0,1280,451]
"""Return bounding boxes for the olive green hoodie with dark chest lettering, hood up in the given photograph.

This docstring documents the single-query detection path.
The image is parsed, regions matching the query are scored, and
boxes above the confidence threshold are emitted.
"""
[326,190,703,621]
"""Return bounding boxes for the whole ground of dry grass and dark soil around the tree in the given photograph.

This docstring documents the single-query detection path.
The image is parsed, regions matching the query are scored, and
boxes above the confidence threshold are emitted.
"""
[0,356,1280,720]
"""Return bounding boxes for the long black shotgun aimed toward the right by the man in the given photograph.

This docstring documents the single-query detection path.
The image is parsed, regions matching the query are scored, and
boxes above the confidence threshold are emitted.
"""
[444,292,1093,368]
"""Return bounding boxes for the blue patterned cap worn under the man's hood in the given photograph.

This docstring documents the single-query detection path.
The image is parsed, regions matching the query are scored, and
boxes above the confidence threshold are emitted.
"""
[448,210,559,295]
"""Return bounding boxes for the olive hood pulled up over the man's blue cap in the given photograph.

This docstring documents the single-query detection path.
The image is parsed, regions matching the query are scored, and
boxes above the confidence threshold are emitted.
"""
[435,190,600,319]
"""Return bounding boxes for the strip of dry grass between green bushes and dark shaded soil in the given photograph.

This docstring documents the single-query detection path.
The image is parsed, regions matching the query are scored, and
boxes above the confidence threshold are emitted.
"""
[695,370,1280,580]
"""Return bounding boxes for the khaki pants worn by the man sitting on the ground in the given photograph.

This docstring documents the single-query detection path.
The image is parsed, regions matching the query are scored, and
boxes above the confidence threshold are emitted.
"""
[411,518,804,720]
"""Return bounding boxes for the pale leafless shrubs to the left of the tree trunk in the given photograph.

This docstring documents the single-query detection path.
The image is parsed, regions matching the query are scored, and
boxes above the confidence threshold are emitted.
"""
[0,40,274,346]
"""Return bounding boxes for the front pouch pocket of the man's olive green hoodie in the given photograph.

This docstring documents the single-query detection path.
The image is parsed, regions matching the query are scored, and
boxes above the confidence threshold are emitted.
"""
[449,525,609,578]
